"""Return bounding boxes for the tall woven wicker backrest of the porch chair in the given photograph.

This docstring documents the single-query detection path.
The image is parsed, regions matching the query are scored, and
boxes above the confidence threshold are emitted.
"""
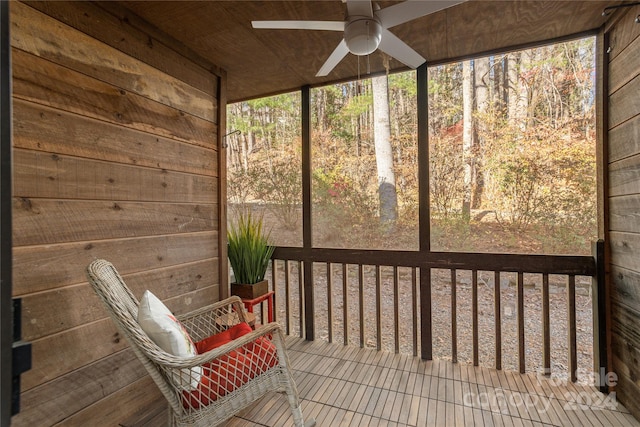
[87,259,181,411]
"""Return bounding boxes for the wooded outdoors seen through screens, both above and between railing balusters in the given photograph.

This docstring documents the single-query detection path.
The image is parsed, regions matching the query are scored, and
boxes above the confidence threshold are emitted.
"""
[226,37,597,380]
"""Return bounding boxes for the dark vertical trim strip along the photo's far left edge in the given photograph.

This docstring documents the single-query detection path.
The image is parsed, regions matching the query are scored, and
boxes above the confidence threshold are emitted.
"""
[0,1,13,427]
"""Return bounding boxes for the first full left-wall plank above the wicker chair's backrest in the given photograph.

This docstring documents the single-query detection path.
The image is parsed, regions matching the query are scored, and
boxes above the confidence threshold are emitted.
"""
[13,197,217,246]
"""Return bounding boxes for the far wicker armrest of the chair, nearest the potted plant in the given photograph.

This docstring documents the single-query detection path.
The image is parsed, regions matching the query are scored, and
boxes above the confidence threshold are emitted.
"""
[176,296,248,342]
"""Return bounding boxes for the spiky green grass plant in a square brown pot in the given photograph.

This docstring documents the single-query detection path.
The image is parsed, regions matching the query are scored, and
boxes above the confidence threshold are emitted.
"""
[227,211,275,299]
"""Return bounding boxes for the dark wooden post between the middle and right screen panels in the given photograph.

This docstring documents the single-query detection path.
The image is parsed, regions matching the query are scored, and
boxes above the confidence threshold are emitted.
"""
[416,63,433,360]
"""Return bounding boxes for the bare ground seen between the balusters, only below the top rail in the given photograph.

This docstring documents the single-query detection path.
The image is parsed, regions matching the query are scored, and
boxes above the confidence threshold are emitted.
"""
[268,262,593,383]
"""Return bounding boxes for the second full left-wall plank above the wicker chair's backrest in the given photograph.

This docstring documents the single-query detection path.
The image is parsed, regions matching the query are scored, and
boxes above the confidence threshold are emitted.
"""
[13,148,217,204]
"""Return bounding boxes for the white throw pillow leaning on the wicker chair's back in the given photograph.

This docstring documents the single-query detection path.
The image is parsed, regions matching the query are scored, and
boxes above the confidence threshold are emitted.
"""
[138,290,202,389]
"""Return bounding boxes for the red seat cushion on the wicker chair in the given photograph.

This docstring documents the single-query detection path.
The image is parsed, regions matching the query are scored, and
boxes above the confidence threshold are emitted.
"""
[182,330,278,409]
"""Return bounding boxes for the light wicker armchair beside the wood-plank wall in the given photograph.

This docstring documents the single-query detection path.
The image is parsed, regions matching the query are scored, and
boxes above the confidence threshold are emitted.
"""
[87,260,315,426]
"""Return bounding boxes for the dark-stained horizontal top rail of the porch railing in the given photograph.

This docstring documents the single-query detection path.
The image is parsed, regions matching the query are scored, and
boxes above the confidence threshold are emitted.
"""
[273,247,596,276]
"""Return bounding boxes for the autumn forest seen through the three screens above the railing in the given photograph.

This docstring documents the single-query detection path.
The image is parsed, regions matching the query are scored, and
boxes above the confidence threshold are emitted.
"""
[226,38,597,254]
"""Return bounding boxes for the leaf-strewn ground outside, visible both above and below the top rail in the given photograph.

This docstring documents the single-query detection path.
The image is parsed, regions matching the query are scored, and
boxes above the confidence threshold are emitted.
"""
[234,206,593,383]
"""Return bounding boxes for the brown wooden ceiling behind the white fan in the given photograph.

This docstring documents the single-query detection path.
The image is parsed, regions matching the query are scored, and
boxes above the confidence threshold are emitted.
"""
[120,0,620,102]
